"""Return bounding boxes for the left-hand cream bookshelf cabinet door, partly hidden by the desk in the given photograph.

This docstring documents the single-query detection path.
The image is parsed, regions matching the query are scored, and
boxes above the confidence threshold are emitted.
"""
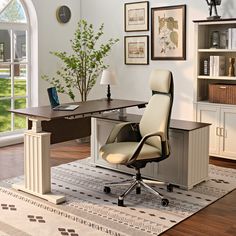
[197,105,220,155]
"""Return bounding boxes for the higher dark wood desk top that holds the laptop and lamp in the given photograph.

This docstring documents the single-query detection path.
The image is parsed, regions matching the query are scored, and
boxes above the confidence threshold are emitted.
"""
[11,99,147,120]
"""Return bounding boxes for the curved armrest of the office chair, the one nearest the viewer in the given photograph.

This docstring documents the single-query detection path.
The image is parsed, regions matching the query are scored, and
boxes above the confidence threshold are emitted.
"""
[128,132,169,165]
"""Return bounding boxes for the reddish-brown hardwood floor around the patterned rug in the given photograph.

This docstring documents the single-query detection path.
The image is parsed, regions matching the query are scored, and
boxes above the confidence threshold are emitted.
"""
[0,141,236,236]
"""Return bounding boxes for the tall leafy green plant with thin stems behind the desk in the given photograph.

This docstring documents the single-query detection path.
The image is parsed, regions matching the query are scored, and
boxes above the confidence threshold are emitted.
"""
[42,19,119,101]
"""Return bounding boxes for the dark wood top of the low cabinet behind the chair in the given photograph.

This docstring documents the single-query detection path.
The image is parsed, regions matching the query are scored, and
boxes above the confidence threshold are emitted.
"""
[94,113,210,131]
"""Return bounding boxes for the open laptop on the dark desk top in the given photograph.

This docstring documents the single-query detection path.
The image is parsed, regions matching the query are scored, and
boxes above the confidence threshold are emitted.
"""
[47,87,79,111]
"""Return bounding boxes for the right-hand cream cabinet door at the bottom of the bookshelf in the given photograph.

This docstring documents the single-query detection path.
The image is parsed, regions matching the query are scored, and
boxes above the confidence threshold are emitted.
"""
[221,108,236,157]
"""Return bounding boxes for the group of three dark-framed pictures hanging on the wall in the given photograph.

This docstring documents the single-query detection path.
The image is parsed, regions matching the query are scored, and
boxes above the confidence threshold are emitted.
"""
[124,1,186,65]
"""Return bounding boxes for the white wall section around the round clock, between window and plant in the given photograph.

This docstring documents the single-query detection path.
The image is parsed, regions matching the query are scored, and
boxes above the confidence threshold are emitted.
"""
[24,0,81,106]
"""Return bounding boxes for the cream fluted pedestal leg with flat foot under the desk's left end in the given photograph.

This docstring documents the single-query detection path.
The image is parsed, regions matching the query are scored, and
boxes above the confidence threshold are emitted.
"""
[12,120,65,204]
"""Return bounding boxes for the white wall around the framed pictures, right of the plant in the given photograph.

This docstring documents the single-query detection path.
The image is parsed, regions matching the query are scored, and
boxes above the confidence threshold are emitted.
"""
[81,0,236,120]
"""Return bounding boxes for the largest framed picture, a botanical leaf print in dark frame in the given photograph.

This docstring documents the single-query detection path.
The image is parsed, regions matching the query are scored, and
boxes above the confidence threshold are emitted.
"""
[151,5,186,60]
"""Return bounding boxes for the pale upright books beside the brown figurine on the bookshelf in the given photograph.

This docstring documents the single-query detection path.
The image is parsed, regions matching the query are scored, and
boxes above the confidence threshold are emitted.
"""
[210,56,225,76]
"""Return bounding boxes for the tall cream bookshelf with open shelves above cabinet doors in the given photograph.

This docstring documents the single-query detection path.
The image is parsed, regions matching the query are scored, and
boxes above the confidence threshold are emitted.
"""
[193,18,236,160]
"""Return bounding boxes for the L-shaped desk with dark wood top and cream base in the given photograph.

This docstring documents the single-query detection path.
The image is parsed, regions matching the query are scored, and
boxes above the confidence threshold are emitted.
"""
[11,99,209,204]
